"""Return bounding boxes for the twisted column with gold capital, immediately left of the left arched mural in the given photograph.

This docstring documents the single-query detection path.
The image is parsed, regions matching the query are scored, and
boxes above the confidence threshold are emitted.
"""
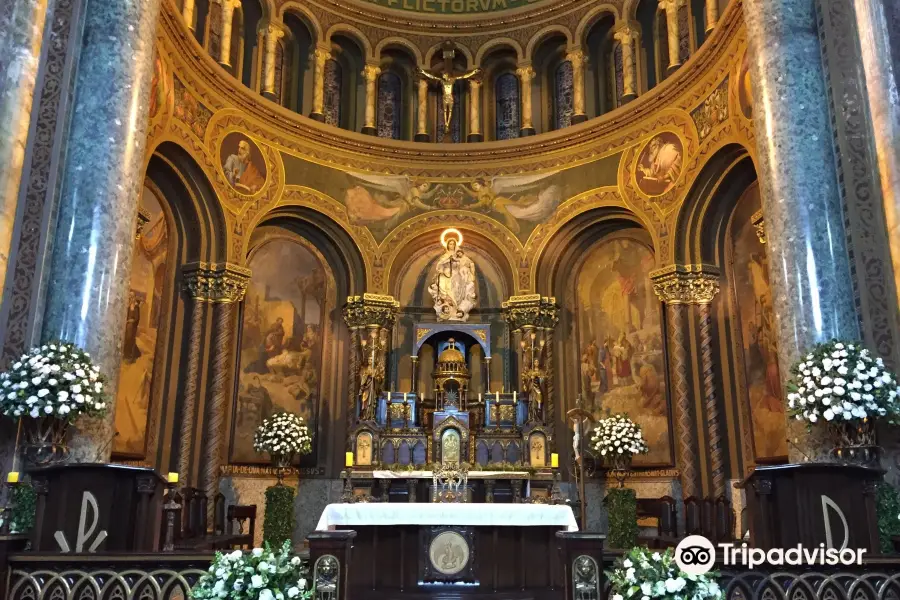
[196,263,251,516]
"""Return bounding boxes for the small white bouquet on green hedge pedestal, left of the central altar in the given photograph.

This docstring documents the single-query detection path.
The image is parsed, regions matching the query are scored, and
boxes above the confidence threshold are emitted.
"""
[253,412,312,547]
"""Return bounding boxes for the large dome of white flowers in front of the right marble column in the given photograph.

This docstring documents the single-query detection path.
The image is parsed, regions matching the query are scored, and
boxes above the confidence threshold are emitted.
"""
[787,340,900,425]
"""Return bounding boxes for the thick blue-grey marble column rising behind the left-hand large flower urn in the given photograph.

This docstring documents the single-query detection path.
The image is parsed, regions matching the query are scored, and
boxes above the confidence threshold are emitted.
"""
[41,0,160,462]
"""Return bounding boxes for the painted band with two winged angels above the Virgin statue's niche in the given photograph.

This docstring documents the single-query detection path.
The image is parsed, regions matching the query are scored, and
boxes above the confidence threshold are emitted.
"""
[282,151,624,242]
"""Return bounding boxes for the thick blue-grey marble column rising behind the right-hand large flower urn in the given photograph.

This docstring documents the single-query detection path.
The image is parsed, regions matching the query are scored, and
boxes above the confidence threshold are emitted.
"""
[744,0,860,461]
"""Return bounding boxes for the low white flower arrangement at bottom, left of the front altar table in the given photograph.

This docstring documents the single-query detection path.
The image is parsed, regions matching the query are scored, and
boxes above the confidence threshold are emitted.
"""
[190,541,315,600]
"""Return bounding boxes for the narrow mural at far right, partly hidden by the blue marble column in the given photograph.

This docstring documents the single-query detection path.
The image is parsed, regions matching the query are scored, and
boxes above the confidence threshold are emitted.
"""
[731,184,788,462]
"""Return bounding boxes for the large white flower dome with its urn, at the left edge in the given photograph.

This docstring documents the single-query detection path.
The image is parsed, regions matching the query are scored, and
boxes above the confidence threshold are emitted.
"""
[0,343,107,465]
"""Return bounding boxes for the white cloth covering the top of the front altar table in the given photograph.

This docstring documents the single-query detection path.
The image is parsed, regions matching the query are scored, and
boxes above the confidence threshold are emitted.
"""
[316,502,578,531]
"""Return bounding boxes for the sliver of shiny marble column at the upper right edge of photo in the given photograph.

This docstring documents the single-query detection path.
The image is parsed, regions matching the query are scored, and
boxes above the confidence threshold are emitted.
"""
[853,0,900,318]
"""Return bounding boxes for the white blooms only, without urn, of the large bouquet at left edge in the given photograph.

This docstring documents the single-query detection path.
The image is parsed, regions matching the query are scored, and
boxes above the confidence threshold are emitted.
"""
[0,343,108,422]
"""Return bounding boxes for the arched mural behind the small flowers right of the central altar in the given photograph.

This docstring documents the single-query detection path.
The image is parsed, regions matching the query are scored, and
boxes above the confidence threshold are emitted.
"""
[574,236,673,465]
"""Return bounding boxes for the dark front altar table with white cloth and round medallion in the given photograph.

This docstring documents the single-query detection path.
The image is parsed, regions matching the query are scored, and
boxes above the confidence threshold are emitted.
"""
[316,502,578,600]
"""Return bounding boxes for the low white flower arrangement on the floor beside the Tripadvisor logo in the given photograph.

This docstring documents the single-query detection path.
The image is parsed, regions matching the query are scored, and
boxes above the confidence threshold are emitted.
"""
[606,547,724,600]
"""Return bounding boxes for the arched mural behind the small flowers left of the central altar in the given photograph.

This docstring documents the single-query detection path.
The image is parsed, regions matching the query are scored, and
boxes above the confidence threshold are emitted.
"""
[231,238,328,463]
